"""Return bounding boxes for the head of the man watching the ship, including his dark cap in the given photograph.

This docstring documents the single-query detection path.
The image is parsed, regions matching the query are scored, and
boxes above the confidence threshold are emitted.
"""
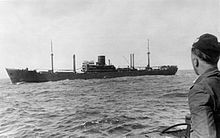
[191,34,220,75]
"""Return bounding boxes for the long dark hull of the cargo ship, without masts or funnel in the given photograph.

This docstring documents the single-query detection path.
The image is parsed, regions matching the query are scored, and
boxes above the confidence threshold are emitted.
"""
[6,68,177,83]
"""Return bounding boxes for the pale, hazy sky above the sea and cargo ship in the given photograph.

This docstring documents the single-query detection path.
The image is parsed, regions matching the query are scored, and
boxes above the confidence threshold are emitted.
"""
[0,0,220,78]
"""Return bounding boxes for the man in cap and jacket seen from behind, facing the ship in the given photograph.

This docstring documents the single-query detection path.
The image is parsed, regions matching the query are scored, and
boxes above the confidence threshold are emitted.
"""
[188,34,220,138]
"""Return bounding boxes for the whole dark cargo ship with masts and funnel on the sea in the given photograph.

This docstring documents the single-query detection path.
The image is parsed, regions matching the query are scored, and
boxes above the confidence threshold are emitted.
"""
[6,40,178,83]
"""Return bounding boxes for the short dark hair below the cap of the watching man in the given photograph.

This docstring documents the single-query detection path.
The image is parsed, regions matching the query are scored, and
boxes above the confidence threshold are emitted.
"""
[192,47,219,65]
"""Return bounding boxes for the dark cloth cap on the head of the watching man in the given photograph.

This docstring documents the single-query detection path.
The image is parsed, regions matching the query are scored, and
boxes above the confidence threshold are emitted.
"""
[192,33,220,57]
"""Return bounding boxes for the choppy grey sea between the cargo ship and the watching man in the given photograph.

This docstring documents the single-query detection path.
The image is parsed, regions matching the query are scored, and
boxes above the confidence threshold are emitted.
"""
[0,70,196,138]
